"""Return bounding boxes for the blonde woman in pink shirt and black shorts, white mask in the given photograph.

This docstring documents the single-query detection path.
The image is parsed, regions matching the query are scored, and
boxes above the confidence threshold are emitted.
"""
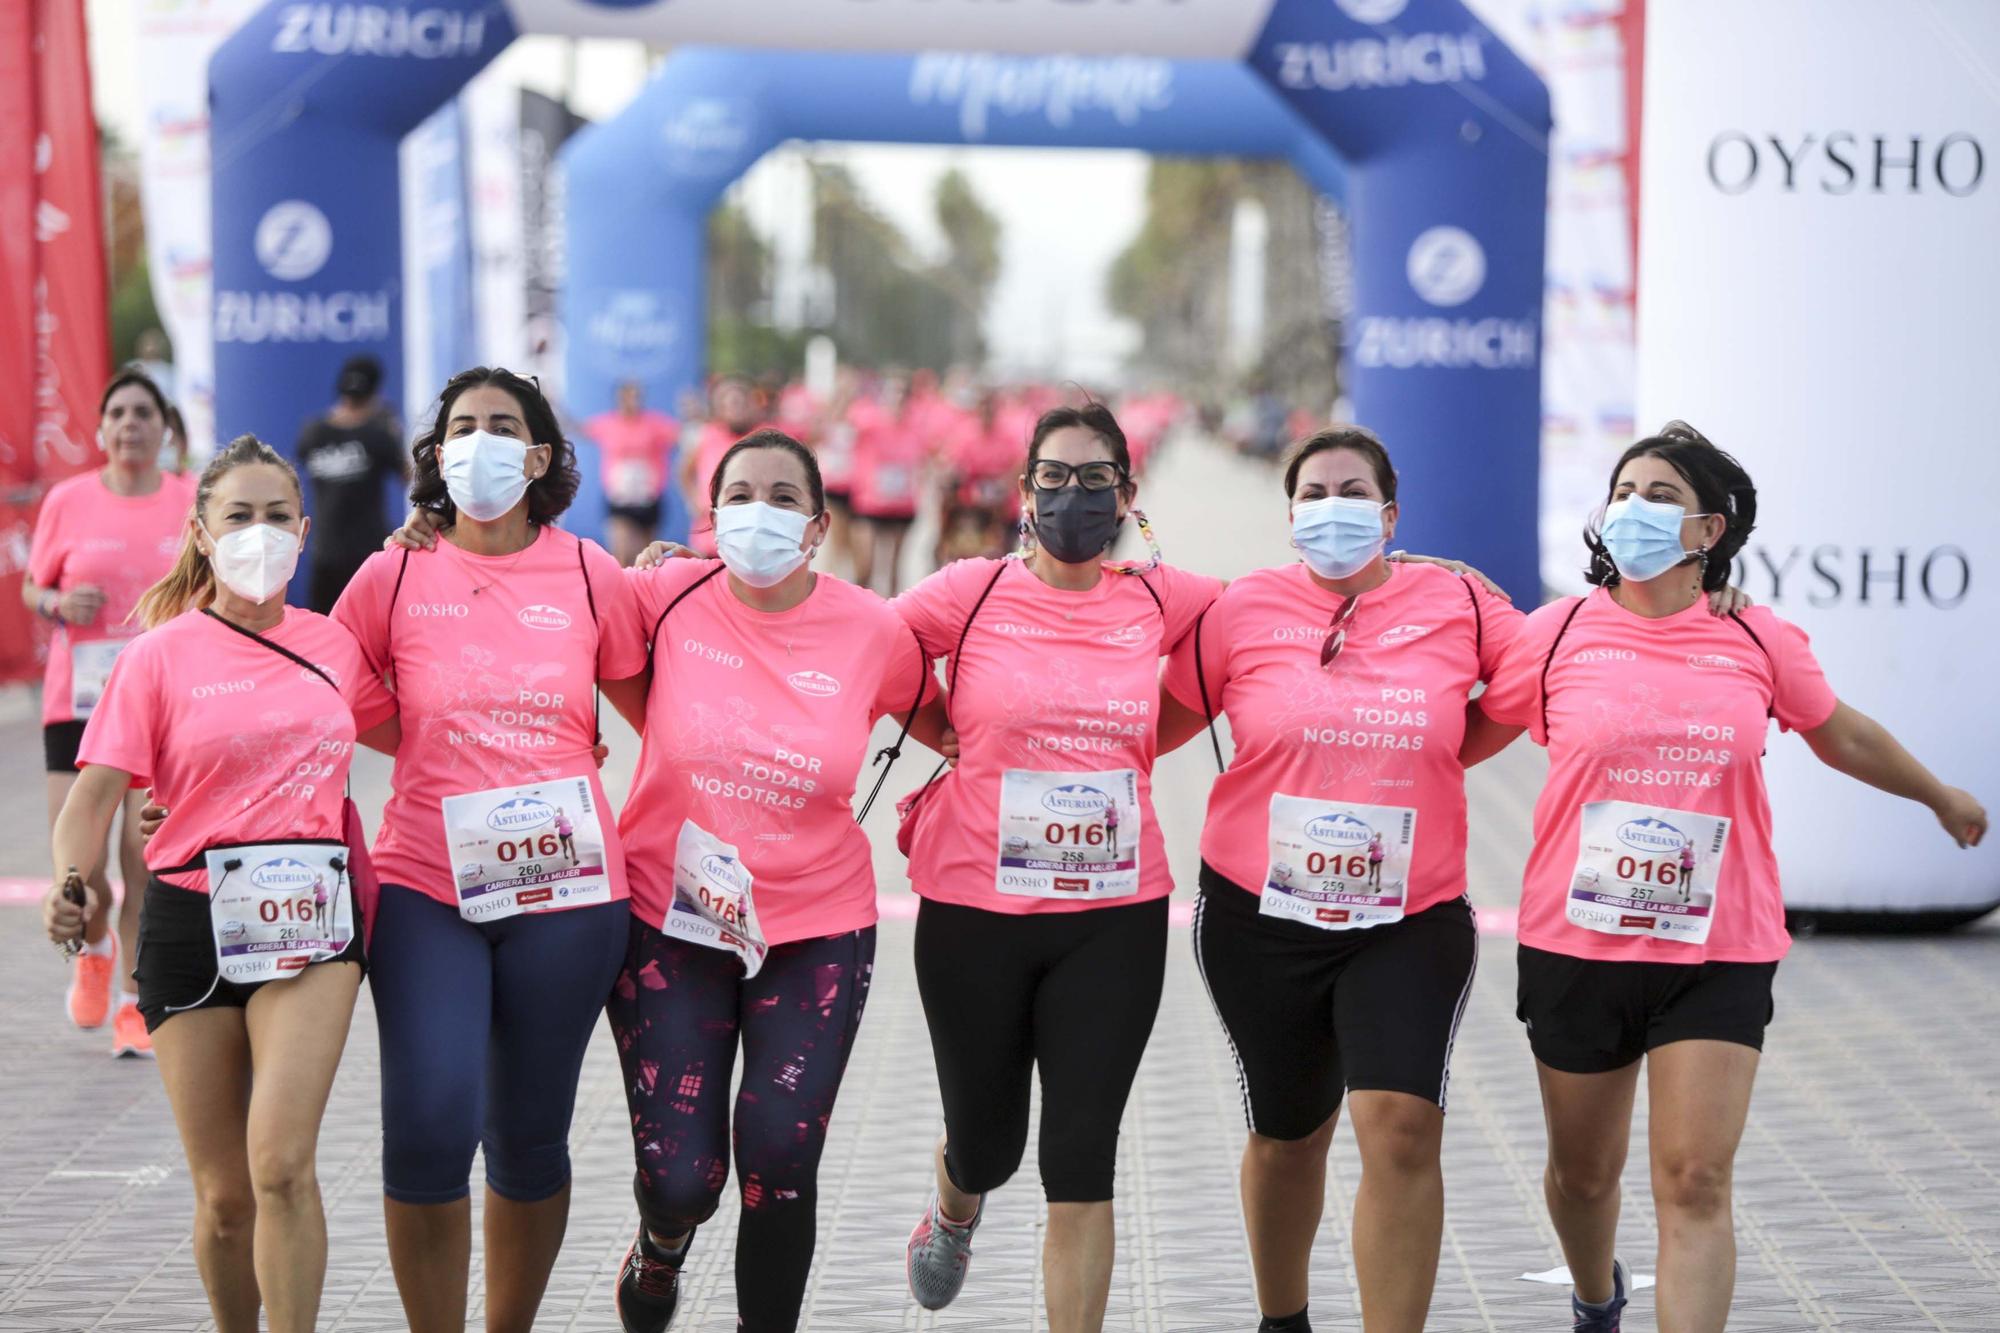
[46,436,396,1333]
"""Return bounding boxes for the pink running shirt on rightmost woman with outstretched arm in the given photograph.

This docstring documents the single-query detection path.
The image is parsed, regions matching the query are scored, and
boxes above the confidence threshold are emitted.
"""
[1480,588,1838,963]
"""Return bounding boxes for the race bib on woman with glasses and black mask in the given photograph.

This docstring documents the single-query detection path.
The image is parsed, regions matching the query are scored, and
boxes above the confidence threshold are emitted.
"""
[994,769,1140,901]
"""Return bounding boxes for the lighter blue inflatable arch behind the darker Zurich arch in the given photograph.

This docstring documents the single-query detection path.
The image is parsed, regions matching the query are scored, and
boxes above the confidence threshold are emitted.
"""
[562,48,1346,544]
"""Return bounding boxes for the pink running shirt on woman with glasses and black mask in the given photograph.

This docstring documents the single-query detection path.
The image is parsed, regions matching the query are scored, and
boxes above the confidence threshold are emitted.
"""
[894,560,1222,915]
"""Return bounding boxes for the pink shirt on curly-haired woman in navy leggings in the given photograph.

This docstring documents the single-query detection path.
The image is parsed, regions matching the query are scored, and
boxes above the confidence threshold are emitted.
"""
[334,528,646,909]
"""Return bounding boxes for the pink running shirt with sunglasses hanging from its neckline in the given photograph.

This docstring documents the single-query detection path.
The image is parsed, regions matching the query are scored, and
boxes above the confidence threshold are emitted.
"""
[1166,564,1526,915]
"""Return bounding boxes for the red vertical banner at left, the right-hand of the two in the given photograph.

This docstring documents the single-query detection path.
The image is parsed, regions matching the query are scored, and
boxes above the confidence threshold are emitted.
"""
[32,0,110,490]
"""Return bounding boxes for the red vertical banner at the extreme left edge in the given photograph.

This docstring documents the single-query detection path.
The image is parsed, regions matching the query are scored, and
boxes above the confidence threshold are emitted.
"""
[0,4,36,681]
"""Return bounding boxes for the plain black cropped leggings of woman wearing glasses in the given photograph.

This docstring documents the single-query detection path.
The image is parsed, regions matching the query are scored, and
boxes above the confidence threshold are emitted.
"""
[916,899,1166,1203]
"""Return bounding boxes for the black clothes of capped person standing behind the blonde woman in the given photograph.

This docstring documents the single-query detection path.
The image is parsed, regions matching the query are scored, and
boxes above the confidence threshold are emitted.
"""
[298,412,404,614]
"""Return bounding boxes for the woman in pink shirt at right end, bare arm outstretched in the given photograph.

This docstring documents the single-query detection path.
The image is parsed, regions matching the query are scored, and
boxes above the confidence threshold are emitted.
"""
[1464,422,1986,1331]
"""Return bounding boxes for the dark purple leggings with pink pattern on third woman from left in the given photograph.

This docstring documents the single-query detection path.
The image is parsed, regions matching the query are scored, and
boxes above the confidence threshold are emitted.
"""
[608,917,874,1333]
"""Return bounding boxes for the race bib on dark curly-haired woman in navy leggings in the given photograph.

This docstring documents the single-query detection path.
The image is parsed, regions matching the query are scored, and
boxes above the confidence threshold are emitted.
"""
[444,777,612,921]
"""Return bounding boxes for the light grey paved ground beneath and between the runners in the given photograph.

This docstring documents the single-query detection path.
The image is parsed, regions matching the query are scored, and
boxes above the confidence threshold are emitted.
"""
[0,442,2000,1333]
